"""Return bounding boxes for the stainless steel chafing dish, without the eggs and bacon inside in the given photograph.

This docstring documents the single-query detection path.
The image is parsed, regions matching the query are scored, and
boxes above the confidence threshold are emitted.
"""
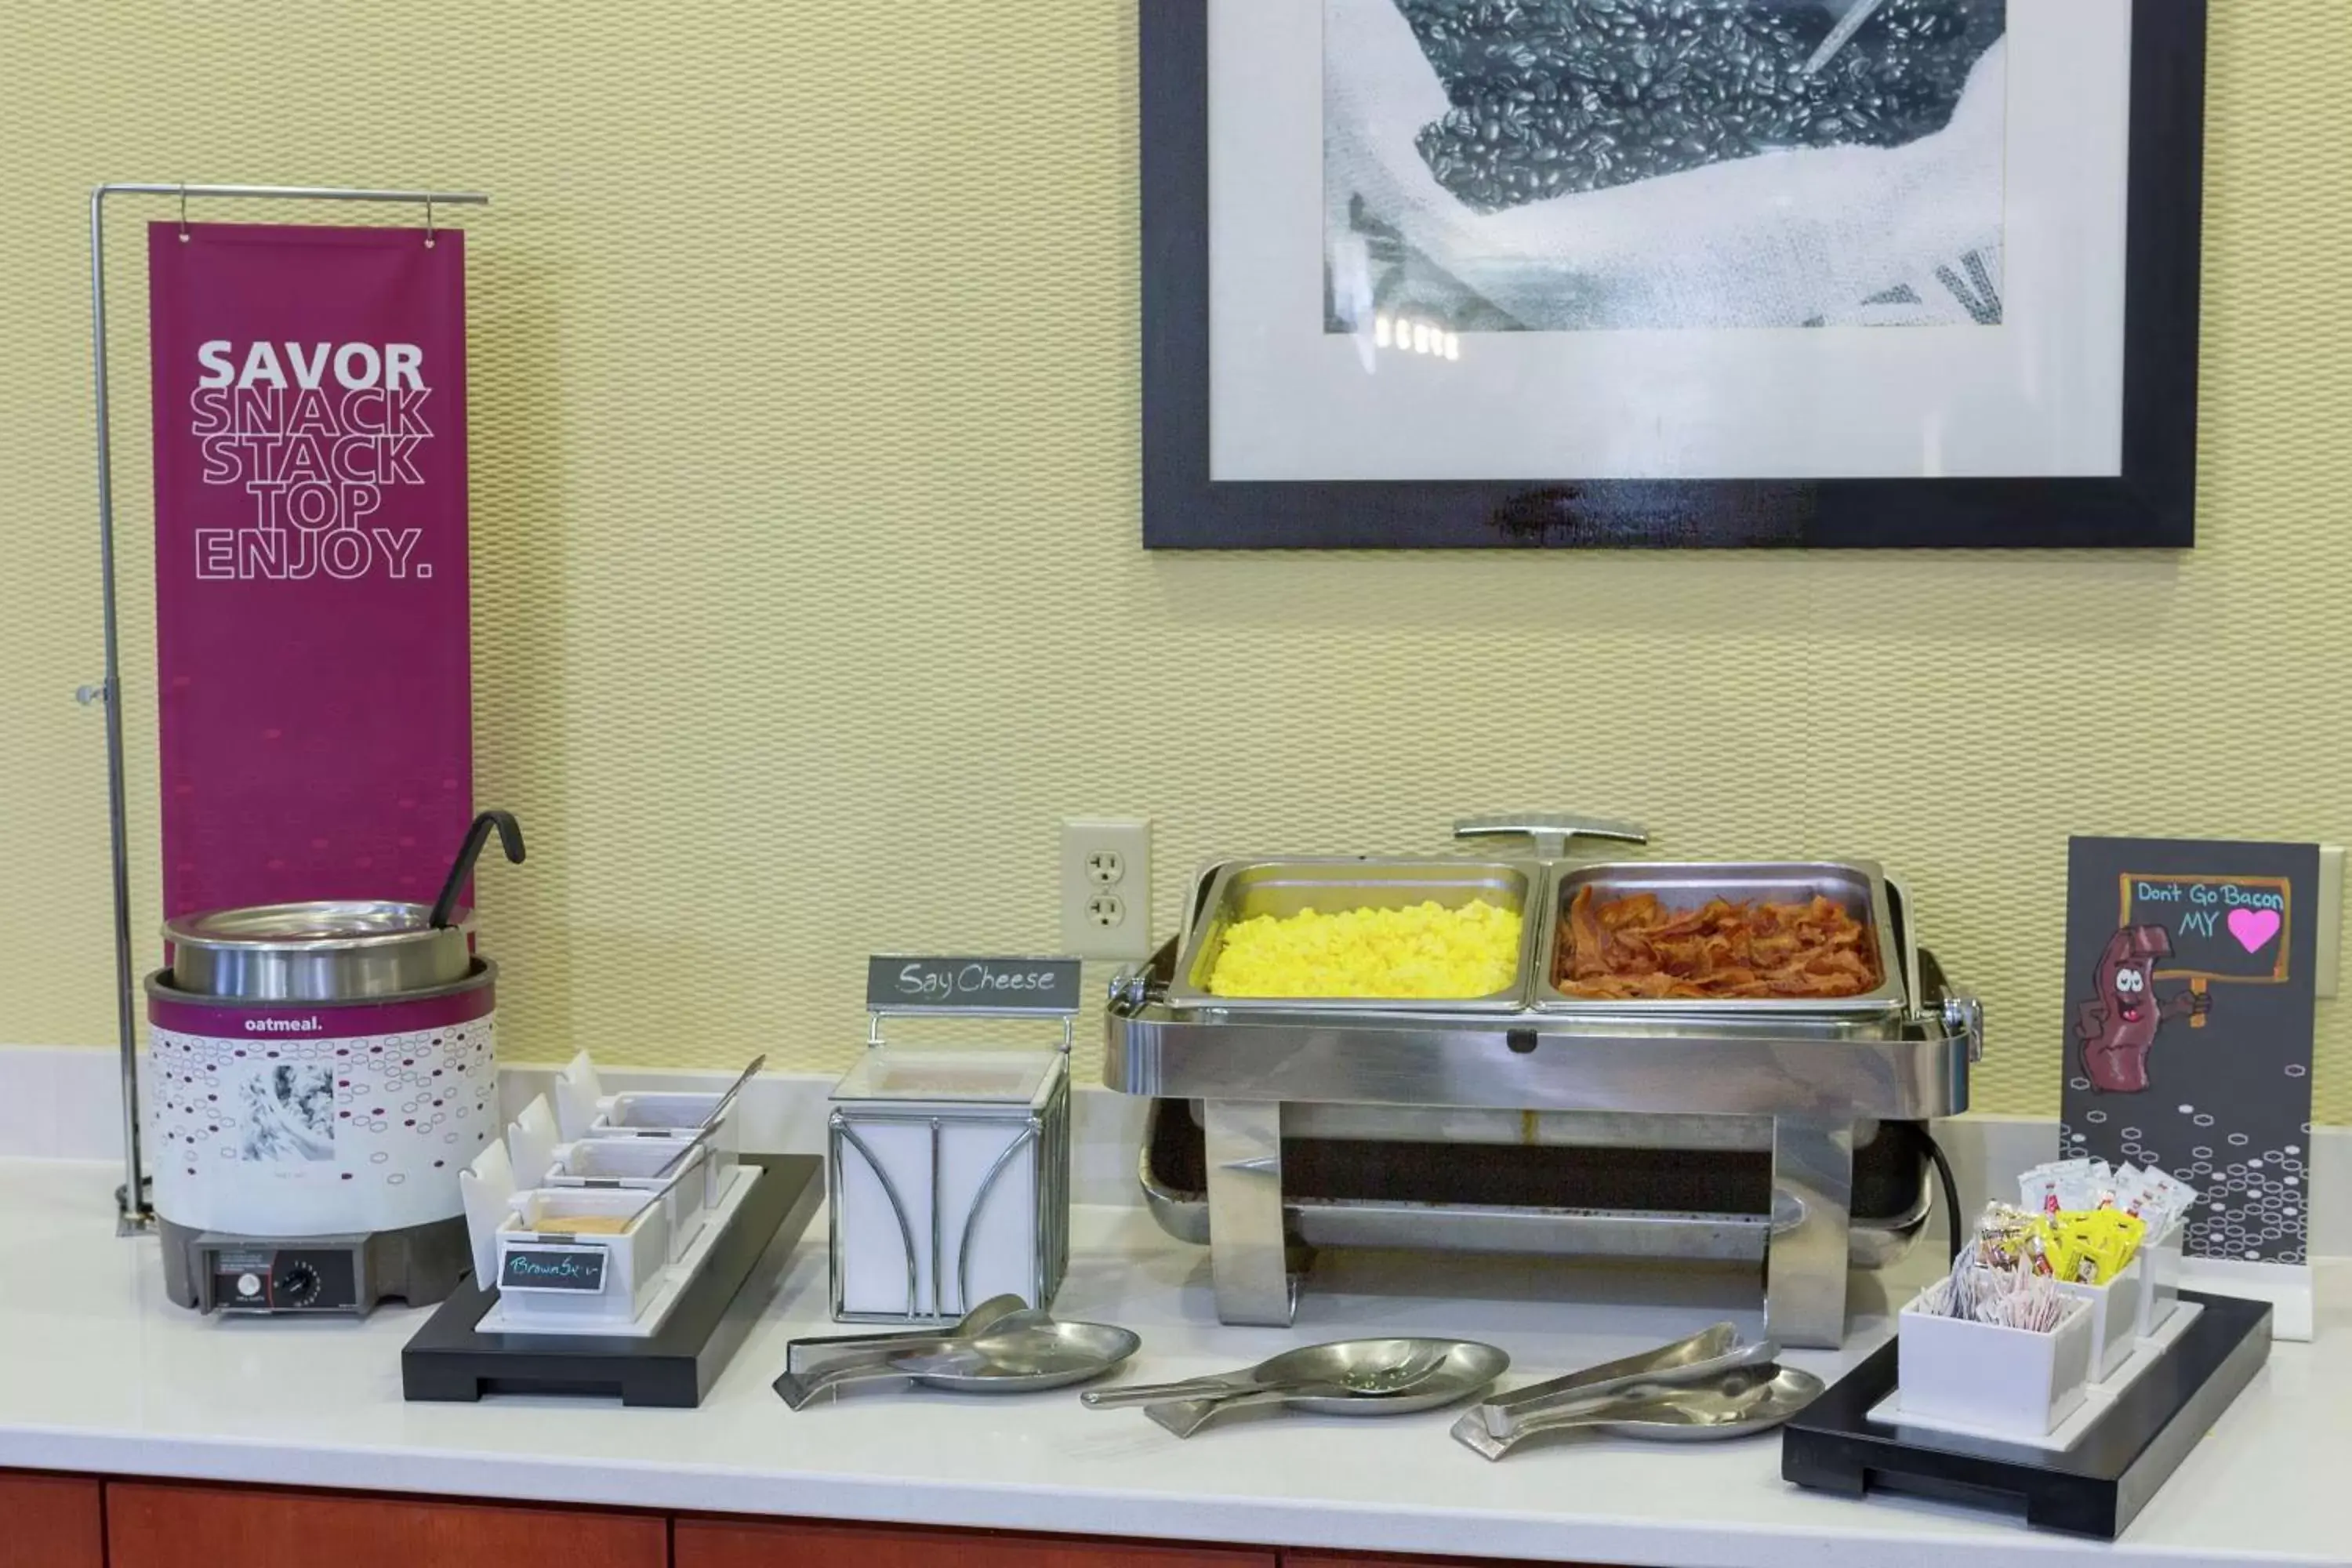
[1103,818,1983,1345]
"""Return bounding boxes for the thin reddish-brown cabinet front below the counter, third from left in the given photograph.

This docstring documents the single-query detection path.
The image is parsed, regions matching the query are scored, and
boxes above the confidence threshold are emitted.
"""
[673,1519,1275,1568]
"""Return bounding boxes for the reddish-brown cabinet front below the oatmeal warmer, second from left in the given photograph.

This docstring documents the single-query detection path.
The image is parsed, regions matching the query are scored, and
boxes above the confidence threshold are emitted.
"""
[106,1481,670,1568]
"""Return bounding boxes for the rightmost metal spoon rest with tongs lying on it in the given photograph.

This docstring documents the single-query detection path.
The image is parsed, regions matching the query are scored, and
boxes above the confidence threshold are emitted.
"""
[1454,1323,1823,1460]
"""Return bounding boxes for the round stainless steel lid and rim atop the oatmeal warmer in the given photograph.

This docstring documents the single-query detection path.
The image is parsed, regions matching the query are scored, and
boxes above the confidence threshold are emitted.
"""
[162,898,473,1001]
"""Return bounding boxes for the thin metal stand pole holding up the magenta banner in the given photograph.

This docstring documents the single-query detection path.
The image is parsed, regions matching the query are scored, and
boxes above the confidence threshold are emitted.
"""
[73,181,489,1236]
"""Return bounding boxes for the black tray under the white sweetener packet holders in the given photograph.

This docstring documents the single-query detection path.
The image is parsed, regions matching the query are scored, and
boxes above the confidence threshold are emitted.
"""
[1780,1290,2270,1540]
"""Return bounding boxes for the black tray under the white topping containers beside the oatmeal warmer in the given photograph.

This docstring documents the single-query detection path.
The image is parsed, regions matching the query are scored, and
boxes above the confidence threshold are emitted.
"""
[400,1154,826,1410]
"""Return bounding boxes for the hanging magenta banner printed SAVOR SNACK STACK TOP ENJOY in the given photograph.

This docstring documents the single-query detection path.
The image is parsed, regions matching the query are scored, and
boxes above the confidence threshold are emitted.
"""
[148,223,473,916]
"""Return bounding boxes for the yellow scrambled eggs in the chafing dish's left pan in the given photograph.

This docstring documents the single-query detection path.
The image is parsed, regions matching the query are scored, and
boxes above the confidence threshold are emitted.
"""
[1209,900,1519,999]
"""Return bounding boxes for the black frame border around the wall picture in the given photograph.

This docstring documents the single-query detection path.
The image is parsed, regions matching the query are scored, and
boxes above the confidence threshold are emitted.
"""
[1138,0,2209,550]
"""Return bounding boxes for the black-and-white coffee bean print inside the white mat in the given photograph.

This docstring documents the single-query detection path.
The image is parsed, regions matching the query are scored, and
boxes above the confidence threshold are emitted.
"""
[1324,0,2009,334]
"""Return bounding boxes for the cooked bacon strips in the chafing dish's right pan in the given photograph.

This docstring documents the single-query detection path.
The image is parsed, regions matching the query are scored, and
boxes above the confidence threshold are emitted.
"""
[1552,886,1879,1001]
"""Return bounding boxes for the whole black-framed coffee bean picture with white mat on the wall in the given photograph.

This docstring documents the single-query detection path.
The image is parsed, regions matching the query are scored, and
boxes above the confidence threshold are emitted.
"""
[1141,0,2206,548]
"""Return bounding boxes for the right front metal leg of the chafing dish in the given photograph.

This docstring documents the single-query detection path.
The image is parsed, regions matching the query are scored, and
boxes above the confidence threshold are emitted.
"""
[1769,1116,1853,1349]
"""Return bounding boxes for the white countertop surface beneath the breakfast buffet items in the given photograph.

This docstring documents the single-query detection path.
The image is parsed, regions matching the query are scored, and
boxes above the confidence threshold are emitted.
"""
[0,1159,2352,1568]
